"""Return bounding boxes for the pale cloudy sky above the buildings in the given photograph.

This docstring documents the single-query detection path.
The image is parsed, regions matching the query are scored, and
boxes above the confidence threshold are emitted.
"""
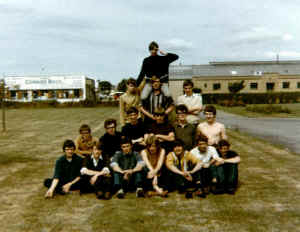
[0,0,300,84]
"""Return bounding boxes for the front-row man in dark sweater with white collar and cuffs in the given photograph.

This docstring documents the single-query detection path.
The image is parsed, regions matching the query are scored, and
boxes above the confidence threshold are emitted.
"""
[80,142,112,200]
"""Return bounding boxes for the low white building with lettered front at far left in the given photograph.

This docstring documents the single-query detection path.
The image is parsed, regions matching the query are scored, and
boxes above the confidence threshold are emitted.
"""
[4,75,95,102]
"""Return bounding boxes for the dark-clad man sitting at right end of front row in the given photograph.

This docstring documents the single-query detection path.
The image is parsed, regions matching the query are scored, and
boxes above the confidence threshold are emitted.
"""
[212,140,241,194]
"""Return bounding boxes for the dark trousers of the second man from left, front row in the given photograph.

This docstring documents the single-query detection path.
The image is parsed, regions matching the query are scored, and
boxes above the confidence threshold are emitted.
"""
[80,175,112,193]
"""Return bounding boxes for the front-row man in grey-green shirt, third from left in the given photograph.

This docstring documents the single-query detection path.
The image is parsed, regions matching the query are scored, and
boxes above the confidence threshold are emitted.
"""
[110,138,145,198]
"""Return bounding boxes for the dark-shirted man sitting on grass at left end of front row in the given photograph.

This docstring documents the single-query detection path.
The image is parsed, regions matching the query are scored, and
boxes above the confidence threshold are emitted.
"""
[44,140,82,198]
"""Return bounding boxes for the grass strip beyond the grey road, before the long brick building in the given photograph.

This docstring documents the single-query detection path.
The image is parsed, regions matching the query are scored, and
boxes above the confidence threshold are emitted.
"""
[216,103,300,118]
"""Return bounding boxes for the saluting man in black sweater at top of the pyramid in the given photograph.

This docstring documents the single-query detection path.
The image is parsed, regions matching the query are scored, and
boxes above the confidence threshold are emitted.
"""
[137,41,179,100]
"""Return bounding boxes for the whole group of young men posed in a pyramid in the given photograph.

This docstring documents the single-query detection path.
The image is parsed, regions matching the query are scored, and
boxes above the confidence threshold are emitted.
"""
[44,42,240,199]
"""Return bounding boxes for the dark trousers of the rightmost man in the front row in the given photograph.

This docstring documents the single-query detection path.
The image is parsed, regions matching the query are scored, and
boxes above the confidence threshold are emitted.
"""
[211,163,238,189]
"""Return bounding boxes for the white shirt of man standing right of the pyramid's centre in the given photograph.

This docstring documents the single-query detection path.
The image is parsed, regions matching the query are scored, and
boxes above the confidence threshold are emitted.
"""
[177,93,203,124]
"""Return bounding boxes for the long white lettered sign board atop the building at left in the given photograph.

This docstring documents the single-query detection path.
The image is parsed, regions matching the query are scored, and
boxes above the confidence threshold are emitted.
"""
[5,76,85,90]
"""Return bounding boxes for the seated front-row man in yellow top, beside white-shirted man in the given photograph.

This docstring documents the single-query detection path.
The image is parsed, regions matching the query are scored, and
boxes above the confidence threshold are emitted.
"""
[166,140,204,198]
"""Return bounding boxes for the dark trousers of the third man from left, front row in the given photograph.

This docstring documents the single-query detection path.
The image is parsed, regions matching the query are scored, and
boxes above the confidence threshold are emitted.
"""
[113,171,145,192]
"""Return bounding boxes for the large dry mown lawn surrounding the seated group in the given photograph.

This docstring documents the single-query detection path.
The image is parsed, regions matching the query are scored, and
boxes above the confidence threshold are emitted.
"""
[0,107,300,232]
